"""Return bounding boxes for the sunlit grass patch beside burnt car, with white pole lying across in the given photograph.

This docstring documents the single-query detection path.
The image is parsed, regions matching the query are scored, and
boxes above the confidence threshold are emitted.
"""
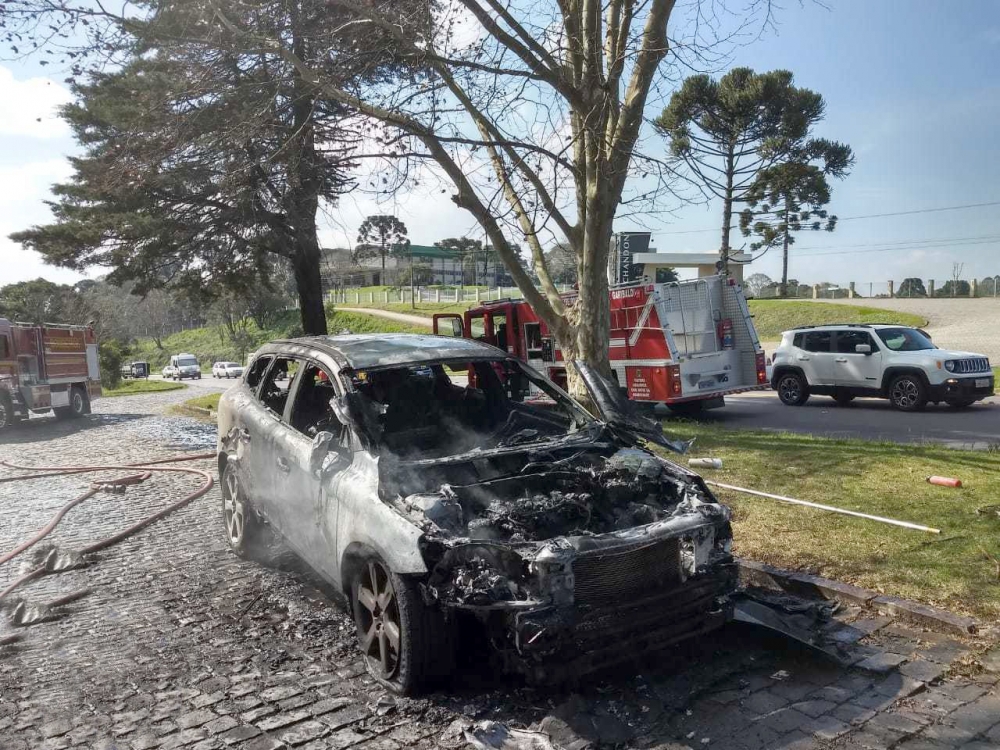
[664,420,1000,620]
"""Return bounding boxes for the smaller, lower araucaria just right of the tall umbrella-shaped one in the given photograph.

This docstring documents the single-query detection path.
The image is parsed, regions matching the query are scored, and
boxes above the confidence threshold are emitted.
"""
[740,138,854,297]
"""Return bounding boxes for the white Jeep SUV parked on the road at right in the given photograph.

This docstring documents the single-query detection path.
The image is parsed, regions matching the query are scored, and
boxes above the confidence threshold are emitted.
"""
[771,324,993,411]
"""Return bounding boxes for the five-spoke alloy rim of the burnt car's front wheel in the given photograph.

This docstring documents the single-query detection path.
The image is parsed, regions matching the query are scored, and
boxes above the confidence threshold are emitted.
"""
[354,560,400,680]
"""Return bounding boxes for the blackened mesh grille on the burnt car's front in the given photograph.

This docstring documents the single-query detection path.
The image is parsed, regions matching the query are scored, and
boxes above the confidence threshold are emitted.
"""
[573,539,681,608]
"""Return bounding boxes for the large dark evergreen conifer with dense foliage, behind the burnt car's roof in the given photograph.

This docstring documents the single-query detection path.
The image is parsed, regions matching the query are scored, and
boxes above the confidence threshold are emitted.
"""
[5,0,364,334]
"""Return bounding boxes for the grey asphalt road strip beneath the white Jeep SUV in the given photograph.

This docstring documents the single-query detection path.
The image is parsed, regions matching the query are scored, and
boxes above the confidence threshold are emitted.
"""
[684,391,1000,450]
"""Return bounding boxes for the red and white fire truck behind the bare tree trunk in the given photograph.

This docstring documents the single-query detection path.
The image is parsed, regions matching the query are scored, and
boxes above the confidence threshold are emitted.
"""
[434,275,768,412]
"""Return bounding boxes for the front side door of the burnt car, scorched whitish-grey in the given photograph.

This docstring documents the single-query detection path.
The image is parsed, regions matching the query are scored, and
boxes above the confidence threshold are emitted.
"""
[272,360,349,580]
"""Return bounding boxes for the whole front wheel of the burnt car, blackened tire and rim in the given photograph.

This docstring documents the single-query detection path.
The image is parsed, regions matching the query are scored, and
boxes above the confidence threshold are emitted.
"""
[350,552,455,695]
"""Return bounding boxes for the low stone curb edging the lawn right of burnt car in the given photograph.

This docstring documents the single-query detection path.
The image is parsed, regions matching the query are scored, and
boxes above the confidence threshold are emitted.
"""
[736,558,979,635]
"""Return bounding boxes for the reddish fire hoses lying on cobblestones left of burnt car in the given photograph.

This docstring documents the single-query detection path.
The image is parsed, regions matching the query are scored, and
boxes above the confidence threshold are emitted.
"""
[0,453,215,620]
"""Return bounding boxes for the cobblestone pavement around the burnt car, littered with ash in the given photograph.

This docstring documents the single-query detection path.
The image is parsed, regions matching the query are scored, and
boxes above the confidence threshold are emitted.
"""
[0,392,1000,750]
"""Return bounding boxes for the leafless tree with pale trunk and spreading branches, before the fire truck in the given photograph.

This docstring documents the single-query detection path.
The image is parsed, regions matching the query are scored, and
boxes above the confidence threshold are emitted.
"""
[2,0,771,393]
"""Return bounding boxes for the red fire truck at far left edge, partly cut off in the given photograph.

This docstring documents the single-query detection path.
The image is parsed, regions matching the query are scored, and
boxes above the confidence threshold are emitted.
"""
[0,318,101,430]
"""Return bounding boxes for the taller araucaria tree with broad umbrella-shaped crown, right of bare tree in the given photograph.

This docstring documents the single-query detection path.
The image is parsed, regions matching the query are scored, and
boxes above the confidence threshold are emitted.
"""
[656,68,836,264]
